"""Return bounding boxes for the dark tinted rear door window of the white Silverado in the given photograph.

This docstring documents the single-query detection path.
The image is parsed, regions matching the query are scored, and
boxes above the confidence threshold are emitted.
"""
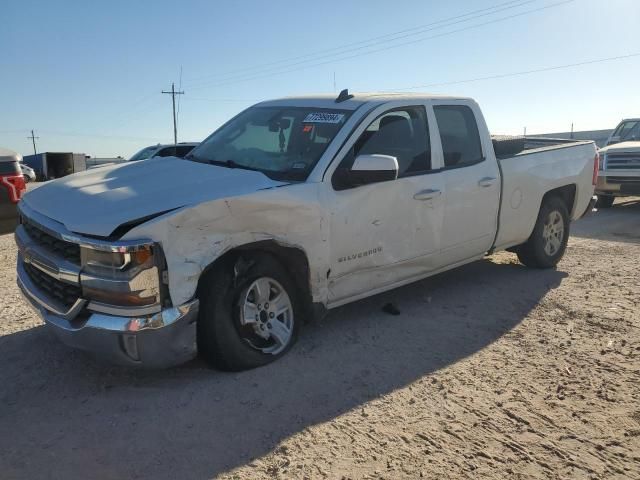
[433,105,482,167]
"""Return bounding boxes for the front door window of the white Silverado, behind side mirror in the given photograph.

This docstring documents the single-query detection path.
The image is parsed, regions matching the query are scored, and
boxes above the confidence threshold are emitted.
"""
[353,107,431,177]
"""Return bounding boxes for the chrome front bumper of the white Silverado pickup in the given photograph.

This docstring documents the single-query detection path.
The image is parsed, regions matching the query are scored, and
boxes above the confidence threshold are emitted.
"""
[18,262,199,368]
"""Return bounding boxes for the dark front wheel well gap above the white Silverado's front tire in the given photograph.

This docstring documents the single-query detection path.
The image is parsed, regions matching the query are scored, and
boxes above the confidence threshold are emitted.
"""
[198,240,312,306]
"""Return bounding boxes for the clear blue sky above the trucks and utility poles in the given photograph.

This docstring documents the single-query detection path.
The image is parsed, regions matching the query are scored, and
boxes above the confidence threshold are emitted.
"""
[0,0,640,157]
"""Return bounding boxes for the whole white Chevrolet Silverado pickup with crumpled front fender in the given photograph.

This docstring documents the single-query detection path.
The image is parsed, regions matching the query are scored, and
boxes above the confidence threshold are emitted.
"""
[16,91,598,370]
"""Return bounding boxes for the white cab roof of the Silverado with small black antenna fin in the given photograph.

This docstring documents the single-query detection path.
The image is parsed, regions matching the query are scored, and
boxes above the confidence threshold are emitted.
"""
[258,92,472,110]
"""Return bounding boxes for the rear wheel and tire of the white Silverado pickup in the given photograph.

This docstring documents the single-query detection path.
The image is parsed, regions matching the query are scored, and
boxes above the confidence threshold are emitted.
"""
[517,197,569,268]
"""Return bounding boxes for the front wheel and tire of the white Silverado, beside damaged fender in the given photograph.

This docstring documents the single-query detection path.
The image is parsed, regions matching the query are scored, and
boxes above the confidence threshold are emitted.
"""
[197,254,303,371]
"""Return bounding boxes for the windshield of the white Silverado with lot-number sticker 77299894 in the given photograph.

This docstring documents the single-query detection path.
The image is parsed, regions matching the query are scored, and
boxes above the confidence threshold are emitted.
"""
[187,107,351,180]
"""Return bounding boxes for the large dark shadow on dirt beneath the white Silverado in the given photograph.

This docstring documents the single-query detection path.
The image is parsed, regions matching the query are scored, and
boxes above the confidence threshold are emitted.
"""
[0,260,566,479]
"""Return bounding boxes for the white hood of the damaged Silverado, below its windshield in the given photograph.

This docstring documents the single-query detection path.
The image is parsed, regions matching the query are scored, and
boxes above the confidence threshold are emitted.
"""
[21,157,283,237]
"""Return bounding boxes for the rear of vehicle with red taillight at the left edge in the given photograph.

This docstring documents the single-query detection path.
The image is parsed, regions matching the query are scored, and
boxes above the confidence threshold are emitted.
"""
[0,148,27,234]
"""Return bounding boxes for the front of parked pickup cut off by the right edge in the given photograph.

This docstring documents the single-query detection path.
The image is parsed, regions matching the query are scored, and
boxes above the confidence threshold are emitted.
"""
[596,118,640,208]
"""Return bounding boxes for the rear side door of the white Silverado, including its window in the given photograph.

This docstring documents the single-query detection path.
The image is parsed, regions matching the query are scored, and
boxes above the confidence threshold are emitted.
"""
[433,100,500,265]
